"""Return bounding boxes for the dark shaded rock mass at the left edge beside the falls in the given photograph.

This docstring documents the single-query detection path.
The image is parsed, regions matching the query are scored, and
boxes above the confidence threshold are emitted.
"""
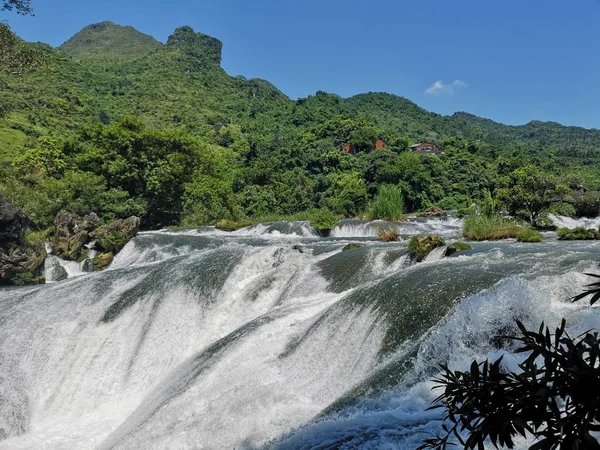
[0,194,46,284]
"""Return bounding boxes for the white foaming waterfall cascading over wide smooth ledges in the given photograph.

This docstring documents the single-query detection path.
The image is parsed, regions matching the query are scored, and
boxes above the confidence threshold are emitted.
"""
[0,218,600,450]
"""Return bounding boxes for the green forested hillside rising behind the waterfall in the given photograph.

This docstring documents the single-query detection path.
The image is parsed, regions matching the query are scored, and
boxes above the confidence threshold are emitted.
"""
[0,22,600,227]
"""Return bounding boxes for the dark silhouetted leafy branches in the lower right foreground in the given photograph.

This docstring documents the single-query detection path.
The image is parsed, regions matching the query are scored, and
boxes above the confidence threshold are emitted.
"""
[419,320,600,450]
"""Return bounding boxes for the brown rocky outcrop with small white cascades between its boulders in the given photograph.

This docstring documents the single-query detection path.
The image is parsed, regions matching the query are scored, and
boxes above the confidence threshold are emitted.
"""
[54,211,140,271]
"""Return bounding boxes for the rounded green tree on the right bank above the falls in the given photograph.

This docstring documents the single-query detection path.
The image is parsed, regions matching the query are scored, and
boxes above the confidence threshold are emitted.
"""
[498,165,568,225]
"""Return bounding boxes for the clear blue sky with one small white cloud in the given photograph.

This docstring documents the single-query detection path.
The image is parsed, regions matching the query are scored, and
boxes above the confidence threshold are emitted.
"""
[2,0,600,128]
